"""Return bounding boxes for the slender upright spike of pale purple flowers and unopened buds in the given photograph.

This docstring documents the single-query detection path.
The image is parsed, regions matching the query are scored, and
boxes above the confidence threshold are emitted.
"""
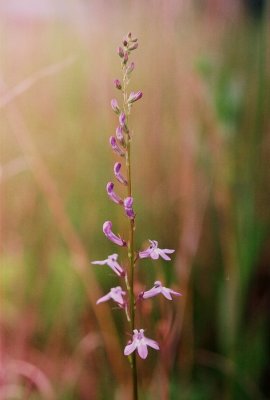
[92,33,181,359]
